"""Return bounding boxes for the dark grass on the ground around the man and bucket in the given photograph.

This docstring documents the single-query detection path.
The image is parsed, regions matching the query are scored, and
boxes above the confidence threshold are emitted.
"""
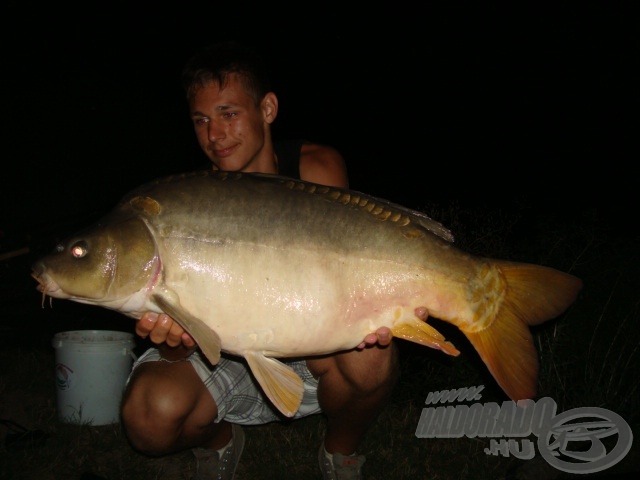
[0,200,640,480]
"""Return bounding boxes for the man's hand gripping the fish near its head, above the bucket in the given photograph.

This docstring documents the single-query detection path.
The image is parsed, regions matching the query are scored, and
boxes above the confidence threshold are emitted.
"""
[136,312,197,360]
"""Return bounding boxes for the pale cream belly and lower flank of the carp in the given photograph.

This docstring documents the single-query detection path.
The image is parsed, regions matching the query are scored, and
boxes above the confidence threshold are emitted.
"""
[156,238,464,357]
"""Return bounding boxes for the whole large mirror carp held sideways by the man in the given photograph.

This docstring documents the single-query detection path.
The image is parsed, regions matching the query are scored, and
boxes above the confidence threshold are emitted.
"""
[32,171,582,417]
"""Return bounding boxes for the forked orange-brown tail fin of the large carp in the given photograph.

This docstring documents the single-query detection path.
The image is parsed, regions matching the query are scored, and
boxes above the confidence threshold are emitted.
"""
[461,260,582,401]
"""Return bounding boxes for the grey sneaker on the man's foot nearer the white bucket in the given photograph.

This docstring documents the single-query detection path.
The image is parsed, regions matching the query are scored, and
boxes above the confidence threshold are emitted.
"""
[191,423,244,480]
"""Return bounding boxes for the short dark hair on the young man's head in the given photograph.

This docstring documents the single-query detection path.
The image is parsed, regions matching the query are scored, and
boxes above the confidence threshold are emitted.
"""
[182,41,271,105]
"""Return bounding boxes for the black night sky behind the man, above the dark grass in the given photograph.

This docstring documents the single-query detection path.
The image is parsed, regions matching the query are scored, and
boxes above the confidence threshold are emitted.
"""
[0,1,640,249]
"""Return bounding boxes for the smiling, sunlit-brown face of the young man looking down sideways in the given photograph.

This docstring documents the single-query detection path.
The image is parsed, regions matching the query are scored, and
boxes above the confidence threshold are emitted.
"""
[189,75,271,171]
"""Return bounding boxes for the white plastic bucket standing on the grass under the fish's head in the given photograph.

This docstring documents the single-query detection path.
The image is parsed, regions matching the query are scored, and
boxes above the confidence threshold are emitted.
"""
[51,330,135,425]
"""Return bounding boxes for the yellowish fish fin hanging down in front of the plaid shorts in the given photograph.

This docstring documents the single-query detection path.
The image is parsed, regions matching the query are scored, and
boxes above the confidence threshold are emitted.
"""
[244,352,304,417]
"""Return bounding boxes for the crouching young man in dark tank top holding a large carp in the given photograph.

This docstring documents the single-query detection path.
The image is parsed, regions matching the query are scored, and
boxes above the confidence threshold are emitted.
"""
[122,43,398,479]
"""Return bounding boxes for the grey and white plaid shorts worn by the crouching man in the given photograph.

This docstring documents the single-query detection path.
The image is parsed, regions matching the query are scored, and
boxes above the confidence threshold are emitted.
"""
[132,348,321,425]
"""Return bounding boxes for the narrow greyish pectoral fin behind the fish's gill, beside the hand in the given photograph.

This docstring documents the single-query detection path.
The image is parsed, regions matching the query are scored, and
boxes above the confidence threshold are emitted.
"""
[152,293,222,365]
